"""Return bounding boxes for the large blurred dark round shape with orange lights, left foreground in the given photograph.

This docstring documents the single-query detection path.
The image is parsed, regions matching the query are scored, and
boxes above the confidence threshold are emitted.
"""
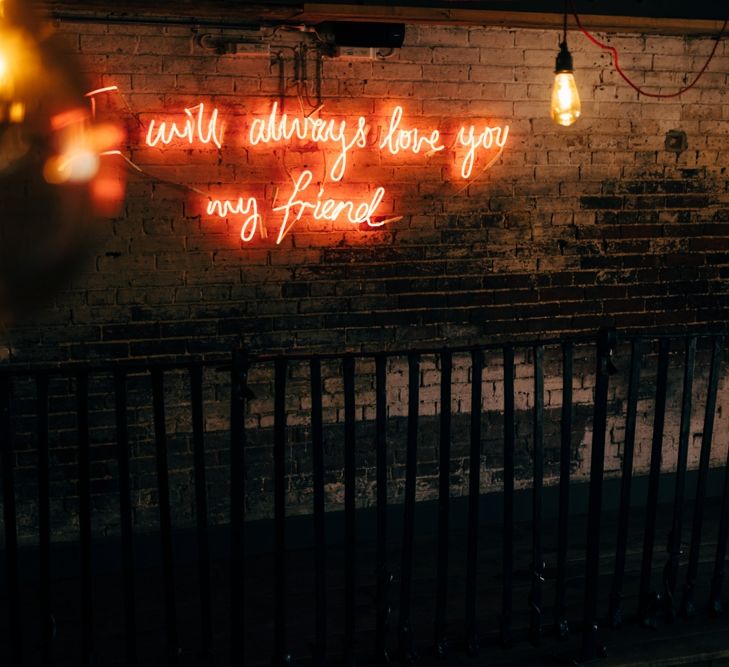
[0,0,124,330]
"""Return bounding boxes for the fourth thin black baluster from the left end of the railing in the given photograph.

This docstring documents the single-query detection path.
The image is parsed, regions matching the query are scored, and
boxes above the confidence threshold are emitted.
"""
[114,369,137,667]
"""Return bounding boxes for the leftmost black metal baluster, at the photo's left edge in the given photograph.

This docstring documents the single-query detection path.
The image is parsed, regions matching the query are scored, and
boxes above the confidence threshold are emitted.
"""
[0,375,23,665]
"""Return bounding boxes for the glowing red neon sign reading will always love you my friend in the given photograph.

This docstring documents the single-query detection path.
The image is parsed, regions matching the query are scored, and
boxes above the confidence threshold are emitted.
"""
[139,102,509,244]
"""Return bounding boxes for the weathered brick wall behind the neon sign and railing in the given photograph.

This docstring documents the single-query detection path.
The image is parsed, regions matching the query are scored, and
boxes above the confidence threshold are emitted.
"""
[0,23,729,540]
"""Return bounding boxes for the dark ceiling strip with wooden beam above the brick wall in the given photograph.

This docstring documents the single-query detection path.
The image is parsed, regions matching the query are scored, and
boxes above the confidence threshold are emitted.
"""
[34,0,729,33]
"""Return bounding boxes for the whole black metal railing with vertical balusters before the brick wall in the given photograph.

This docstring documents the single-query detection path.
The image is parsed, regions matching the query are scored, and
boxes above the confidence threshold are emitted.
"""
[0,331,729,665]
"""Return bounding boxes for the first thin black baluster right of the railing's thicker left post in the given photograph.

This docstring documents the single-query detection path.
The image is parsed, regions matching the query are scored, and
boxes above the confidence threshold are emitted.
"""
[273,357,291,667]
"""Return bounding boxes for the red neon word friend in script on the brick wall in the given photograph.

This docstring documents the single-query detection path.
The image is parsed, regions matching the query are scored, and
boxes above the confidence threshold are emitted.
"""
[273,169,385,244]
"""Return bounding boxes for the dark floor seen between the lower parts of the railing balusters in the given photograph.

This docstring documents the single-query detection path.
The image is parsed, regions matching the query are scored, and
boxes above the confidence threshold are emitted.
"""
[0,488,729,667]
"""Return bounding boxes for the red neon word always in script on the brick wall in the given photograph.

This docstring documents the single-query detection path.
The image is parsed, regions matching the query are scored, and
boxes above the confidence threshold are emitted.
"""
[248,102,369,181]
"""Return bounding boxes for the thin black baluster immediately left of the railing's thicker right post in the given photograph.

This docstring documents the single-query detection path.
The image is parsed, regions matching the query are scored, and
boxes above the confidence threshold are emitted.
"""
[554,343,572,639]
